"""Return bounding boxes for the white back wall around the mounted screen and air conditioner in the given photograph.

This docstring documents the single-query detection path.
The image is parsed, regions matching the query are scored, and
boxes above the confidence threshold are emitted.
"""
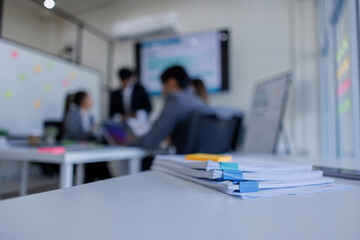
[73,0,320,156]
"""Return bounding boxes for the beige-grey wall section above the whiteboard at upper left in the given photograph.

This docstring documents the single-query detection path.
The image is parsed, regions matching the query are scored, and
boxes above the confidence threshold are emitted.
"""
[2,0,76,54]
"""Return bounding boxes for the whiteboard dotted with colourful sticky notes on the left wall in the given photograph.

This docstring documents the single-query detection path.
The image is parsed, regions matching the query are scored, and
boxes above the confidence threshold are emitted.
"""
[0,39,101,135]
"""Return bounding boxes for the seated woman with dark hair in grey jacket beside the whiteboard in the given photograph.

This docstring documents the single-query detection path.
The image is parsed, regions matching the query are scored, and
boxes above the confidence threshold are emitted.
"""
[64,91,111,183]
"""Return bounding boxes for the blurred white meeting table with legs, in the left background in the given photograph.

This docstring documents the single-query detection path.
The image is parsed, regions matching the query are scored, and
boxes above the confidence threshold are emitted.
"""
[0,146,146,196]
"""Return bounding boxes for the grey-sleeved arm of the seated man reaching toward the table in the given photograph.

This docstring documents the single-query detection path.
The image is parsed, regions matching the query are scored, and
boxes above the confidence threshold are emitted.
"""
[130,96,181,149]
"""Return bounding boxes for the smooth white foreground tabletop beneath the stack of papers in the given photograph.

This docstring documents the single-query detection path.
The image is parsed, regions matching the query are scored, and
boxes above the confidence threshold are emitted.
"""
[0,171,360,240]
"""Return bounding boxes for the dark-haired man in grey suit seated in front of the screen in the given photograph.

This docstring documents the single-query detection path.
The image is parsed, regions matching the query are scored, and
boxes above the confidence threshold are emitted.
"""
[130,66,207,153]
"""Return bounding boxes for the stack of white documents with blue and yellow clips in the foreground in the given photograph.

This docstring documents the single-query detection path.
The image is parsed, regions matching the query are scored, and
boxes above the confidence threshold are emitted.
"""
[152,155,348,199]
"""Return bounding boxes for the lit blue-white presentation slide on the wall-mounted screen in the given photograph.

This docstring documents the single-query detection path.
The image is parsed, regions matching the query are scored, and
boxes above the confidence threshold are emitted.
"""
[137,31,228,94]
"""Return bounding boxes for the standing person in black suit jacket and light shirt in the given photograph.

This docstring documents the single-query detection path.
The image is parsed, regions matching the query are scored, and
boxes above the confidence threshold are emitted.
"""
[110,68,151,118]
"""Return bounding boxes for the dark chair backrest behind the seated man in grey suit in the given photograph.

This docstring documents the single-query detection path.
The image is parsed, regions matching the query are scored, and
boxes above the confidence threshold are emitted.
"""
[177,108,244,154]
